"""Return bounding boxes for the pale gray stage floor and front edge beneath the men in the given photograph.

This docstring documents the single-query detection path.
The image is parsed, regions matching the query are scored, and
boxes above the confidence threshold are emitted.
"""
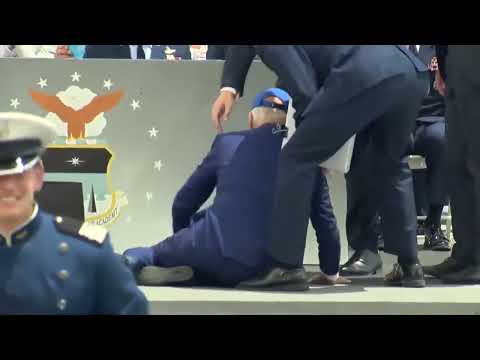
[142,245,480,315]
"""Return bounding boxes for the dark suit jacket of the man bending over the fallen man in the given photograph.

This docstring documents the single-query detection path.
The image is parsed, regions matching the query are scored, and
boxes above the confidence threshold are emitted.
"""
[222,45,427,120]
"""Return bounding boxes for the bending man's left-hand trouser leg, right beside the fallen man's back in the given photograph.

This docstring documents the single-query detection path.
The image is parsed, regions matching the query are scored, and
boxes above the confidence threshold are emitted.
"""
[267,76,412,267]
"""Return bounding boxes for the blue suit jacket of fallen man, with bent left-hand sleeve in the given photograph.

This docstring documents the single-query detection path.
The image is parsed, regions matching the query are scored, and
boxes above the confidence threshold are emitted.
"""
[172,125,282,268]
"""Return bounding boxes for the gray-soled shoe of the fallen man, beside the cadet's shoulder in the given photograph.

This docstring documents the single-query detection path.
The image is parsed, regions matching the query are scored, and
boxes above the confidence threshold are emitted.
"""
[136,266,194,286]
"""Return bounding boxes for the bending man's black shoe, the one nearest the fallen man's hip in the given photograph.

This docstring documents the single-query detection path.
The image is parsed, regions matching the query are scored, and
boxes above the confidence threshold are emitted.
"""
[236,267,310,291]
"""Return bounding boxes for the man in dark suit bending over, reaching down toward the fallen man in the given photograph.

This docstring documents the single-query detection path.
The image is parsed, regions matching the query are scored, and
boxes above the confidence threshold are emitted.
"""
[212,45,428,289]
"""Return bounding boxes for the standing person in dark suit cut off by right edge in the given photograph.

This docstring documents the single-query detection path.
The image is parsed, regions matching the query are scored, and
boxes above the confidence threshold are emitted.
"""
[425,45,480,284]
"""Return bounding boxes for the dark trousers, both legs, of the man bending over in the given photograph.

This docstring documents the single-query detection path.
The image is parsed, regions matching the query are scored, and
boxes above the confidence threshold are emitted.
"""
[268,67,428,266]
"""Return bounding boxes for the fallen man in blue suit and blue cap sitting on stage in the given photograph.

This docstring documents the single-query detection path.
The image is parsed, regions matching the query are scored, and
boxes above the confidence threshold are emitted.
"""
[124,88,344,290]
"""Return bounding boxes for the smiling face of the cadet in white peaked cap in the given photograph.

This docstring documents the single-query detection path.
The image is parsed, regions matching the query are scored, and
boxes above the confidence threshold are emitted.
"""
[0,164,44,223]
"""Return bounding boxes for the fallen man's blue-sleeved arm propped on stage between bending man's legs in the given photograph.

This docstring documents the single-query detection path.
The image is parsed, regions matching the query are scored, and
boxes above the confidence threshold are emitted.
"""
[310,167,340,276]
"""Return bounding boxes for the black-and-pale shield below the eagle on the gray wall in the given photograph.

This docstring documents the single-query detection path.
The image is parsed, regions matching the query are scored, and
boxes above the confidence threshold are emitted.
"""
[39,145,127,226]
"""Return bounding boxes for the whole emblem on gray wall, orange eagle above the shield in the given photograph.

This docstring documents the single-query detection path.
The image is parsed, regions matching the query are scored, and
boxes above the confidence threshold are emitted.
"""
[29,82,127,227]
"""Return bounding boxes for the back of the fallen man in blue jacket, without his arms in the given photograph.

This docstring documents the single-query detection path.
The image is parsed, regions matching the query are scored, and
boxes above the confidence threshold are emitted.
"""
[201,124,283,267]
